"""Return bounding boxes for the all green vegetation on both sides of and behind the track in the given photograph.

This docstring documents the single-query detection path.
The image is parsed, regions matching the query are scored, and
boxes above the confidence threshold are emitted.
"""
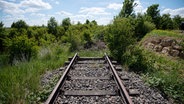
[0,0,184,104]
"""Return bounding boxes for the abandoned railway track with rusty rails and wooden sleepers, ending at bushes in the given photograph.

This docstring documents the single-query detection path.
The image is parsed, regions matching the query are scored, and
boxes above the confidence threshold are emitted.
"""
[45,53,133,104]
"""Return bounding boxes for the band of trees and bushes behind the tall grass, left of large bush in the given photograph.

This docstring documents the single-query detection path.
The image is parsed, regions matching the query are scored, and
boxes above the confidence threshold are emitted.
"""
[0,17,103,64]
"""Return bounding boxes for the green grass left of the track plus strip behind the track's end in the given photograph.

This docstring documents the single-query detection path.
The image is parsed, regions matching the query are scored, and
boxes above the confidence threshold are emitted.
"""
[0,43,108,104]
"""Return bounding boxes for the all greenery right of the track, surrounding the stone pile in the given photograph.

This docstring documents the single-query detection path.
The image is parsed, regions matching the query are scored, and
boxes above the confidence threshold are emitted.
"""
[105,0,184,102]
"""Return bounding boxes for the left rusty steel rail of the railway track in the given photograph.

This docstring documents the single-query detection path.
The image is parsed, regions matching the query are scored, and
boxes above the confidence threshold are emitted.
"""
[45,53,77,104]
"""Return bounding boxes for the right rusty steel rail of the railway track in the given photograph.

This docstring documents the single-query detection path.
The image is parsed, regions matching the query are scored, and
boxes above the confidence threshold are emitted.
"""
[105,53,133,104]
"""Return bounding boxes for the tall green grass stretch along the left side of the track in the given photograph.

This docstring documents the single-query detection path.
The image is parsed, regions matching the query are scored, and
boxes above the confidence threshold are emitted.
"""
[0,43,71,104]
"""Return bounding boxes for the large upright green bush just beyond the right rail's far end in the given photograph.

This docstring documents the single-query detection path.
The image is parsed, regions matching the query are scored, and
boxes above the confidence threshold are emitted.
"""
[106,18,135,61]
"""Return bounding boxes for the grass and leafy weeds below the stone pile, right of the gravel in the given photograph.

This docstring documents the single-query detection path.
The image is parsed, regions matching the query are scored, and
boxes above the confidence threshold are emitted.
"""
[143,49,184,102]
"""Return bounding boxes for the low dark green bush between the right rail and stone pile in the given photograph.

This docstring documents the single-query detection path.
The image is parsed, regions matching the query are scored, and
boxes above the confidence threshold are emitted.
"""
[122,46,154,72]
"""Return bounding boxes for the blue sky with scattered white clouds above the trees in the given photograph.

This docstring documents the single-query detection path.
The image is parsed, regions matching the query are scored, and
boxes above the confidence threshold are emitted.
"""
[0,0,184,27]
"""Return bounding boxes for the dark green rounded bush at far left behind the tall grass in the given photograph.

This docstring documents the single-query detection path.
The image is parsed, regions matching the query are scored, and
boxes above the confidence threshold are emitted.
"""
[8,35,37,64]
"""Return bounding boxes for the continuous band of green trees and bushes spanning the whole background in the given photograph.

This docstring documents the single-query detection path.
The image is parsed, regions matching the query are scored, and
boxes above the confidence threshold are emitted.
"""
[0,0,184,64]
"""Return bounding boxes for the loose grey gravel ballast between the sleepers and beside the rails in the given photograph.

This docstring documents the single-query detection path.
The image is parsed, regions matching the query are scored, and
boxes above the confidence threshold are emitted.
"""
[41,60,171,104]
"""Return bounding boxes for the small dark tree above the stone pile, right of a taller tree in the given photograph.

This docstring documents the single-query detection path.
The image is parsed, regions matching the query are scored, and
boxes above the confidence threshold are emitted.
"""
[160,14,173,30]
